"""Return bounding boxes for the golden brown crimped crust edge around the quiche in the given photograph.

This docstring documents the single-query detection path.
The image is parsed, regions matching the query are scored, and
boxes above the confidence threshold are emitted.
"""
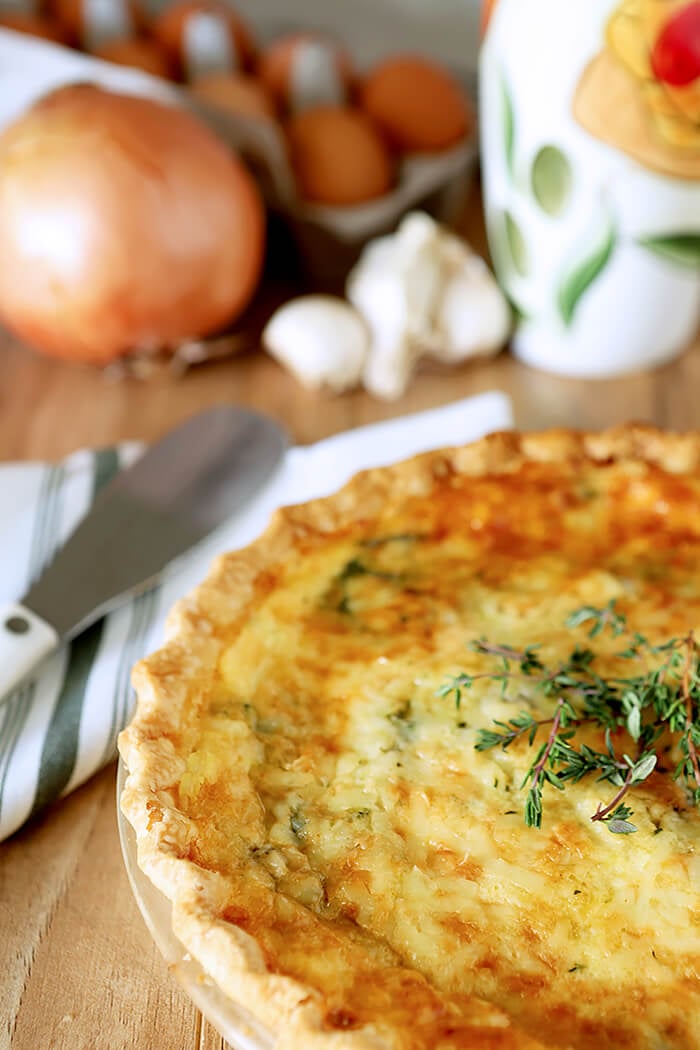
[120,425,700,1050]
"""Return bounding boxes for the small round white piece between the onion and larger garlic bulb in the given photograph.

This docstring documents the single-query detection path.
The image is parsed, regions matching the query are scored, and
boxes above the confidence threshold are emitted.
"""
[262,295,369,394]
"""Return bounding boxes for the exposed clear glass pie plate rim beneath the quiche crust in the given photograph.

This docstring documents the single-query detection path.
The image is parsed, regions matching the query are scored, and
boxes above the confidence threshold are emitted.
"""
[116,758,276,1050]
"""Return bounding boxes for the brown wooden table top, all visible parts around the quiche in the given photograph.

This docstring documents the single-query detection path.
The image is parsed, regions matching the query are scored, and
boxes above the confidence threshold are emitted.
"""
[0,191,700,1050]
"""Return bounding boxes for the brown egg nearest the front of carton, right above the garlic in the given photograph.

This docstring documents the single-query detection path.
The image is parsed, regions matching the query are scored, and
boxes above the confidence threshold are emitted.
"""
[287,106,395,205]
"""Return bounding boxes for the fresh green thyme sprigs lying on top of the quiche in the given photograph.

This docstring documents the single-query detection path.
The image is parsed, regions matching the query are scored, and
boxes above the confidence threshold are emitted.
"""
[438,601,700,835]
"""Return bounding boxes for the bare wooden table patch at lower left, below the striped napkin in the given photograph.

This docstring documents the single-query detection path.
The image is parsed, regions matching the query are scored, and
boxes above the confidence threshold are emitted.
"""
[0,765,199,1050]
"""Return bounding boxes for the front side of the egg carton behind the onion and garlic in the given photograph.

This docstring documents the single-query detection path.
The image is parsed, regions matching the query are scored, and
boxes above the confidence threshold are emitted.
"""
[0,28,478,291]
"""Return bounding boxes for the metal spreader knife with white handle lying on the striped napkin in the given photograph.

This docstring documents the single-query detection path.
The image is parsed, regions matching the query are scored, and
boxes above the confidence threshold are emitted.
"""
[0,405,288,702]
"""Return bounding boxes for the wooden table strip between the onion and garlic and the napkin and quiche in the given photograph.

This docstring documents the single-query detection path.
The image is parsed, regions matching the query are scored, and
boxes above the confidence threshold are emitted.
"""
[0,323,700,460]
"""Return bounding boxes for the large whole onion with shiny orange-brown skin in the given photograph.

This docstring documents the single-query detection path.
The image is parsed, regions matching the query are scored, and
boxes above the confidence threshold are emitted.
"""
[0,84,264,364]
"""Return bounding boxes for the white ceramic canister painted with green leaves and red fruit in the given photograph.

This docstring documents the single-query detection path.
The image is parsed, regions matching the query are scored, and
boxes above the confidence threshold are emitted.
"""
[480,0,700,377]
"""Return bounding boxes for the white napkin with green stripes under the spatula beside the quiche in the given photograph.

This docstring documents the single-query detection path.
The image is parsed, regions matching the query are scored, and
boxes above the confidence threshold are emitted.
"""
[0,392,512,840]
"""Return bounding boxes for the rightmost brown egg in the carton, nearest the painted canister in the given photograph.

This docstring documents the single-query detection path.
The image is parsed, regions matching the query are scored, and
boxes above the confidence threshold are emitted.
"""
[360,55,474,153]
